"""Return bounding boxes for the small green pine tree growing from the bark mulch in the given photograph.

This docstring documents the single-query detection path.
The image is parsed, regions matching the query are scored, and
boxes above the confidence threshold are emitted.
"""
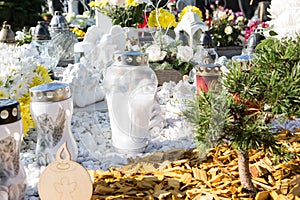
[184,36,300,194]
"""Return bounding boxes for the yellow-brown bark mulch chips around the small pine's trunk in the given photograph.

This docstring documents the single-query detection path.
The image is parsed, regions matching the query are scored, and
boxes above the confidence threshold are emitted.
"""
[89,131,300,200]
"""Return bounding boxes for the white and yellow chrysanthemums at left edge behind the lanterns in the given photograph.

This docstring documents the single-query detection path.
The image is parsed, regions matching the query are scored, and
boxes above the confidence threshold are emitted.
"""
[0,43,52,134]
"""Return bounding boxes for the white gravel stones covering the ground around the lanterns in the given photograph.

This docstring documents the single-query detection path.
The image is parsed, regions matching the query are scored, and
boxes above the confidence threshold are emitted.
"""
[21,82,300,200]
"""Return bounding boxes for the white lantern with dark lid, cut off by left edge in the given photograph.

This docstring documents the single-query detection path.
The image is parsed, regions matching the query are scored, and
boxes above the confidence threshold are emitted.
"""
[0,99,26,200]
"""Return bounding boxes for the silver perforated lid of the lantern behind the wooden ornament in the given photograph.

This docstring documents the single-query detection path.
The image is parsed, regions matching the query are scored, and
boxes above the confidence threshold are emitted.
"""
[29,82,71,102]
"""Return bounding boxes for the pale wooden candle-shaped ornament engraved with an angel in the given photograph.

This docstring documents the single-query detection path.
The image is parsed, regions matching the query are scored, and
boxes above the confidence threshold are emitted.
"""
[38,142,93,200]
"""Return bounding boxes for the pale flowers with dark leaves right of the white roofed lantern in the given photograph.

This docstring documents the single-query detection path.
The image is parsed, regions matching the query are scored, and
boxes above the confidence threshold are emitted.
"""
[205,1,246,47]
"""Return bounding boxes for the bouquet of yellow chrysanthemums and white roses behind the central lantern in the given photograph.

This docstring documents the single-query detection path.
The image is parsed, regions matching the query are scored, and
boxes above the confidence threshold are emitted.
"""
[145,6,202,75]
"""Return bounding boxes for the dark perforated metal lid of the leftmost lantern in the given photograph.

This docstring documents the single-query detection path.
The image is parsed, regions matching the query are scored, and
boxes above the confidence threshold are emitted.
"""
[0,99,21,125]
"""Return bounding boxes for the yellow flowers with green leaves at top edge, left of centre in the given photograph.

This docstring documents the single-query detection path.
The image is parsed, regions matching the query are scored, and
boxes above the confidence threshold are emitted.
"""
[89,0,147,27]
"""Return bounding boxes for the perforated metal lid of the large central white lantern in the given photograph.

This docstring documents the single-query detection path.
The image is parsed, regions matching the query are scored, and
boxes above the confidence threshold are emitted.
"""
[113,51,149,66]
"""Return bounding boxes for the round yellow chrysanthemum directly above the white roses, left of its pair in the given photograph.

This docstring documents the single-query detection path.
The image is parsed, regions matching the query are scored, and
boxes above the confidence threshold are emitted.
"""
[148,8,177,29]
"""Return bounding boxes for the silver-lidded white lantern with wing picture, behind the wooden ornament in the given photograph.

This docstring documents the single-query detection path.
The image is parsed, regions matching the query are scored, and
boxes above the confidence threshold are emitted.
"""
[30,82,78,165]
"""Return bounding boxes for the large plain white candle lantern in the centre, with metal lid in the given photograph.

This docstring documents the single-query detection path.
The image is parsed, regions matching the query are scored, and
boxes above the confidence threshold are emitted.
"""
[104,52,157,153]
